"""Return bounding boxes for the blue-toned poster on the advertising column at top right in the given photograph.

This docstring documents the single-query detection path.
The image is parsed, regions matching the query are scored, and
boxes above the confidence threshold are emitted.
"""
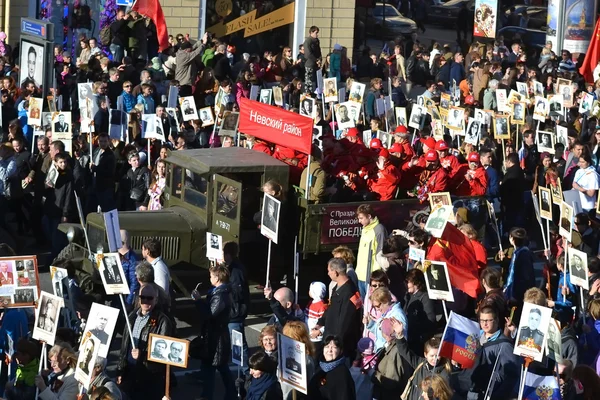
[563,0,596,53]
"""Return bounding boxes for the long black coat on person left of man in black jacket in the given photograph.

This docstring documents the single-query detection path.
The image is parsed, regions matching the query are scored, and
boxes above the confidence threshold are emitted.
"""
[198,284,231,367]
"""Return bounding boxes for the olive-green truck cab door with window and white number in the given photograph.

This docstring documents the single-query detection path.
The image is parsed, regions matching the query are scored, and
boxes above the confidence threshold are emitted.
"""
[211,174,242,243]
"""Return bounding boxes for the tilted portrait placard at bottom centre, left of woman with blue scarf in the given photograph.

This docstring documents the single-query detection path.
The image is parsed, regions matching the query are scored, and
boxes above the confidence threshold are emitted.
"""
[277,333,308,394]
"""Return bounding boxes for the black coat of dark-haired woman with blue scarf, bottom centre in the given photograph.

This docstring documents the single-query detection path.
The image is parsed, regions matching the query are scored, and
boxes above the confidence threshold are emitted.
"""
[308,362,356,400]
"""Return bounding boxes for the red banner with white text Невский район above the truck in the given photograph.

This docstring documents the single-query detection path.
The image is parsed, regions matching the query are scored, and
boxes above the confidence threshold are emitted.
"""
[239,98,313,154]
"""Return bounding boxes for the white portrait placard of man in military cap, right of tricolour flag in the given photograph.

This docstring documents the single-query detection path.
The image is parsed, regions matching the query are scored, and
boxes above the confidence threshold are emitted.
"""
[514,303,552,361]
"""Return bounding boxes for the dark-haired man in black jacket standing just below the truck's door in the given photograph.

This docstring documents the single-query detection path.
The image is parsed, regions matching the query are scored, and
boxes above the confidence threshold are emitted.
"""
[223,242,250,376]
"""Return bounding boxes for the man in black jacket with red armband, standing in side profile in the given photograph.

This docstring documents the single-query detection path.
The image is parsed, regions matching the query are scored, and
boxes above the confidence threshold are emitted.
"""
[310,258,362,360]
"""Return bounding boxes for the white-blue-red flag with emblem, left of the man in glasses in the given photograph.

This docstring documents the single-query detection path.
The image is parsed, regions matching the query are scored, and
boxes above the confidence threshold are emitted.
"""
[440,311,479,369]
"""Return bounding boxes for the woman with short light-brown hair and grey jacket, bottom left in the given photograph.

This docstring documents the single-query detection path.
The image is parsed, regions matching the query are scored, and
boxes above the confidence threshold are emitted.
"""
[35,343,79,400]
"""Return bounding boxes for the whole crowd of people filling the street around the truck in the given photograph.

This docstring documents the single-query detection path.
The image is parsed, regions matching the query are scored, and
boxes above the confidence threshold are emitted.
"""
[0,1,600,400]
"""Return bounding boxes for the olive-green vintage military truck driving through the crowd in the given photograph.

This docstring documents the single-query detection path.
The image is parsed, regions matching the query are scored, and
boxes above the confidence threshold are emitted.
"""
[60,147,490,293]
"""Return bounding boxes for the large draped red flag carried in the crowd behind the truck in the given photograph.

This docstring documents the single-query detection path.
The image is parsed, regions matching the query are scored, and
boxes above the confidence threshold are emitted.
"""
[426,223,479,298]
